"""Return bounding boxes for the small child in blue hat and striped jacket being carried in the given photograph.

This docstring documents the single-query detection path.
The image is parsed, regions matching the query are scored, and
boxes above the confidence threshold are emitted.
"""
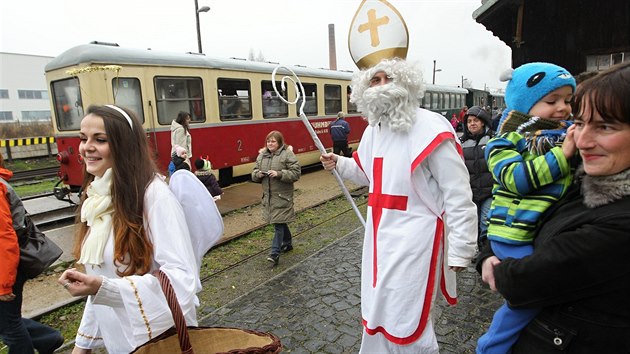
[477,63,576,354]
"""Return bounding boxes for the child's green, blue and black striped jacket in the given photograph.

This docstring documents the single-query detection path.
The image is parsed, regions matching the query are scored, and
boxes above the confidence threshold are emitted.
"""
[486,132,573,245]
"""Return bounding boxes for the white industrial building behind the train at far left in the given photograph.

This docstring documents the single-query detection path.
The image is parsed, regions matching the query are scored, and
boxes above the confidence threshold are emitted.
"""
[0,52,53,124]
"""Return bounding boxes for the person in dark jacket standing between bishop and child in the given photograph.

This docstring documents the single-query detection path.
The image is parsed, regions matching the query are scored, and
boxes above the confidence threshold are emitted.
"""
[460,106,494,249]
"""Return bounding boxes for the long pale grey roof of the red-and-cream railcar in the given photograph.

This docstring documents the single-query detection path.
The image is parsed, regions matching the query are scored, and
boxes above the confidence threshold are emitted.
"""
[45,43,352,80]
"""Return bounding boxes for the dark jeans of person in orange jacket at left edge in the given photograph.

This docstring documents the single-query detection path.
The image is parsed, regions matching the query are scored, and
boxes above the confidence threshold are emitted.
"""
[0,271,63,354]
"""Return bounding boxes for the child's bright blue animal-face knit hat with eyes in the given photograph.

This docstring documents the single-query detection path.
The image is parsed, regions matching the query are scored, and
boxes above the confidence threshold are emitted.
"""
[500,63,575,114]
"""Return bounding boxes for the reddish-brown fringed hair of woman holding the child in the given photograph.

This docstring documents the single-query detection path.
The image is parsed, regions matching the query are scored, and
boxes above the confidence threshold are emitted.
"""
[575,61,630,124]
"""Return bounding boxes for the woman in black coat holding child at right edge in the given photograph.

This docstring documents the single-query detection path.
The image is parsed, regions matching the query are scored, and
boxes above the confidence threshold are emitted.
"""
[477,62,630,354]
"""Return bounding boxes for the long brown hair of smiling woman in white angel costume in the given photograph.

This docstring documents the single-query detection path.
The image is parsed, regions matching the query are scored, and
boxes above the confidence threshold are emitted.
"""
[74,105,157,276]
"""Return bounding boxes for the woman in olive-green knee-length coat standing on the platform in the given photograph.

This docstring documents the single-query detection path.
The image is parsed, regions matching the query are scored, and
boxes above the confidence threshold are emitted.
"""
[252,130,302,266]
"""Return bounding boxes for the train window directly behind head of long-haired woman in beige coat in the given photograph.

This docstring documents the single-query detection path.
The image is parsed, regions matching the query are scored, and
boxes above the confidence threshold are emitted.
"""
[155,77,205,124]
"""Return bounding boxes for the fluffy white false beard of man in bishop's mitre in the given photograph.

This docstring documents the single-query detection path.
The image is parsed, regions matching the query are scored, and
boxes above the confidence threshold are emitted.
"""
[362,83,417,133]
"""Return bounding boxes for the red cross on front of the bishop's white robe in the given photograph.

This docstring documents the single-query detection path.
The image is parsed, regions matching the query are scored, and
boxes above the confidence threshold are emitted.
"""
[368,157,408,287]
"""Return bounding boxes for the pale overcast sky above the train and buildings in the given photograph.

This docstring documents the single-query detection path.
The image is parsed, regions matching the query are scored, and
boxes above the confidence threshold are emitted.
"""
[0,0,511,89]
